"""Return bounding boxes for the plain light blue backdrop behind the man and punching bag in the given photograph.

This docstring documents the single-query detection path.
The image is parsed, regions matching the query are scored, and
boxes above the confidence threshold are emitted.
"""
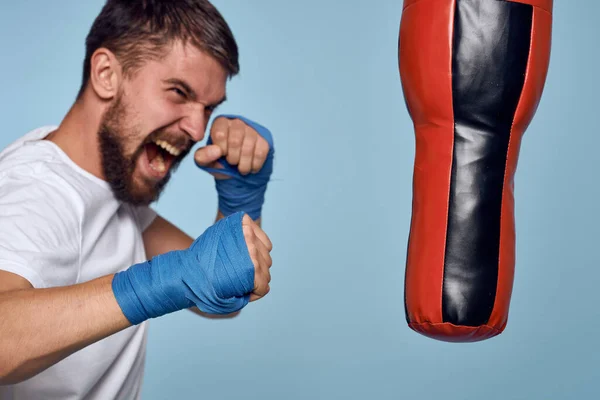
[0,0,600,400]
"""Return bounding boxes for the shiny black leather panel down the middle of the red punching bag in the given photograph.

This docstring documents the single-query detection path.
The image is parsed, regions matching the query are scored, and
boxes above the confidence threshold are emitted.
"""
[442,0,533,326]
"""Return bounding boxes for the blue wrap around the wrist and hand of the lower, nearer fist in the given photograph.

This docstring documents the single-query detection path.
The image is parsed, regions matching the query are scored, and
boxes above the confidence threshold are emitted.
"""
[112,212,254,325]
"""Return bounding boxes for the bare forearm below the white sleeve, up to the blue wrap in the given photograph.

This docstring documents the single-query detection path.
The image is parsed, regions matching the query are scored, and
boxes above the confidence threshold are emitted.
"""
[0,275,130,385]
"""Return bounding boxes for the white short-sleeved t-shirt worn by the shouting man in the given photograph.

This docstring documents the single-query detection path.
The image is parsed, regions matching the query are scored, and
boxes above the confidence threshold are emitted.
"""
[0,127,156,400]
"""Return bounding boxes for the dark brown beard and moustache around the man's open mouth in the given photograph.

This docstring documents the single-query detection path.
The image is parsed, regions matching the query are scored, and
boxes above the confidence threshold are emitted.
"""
[98,93,189,206]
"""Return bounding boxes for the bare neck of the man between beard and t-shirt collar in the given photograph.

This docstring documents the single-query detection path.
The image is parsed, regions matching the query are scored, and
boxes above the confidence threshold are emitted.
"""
[46,94,105,179]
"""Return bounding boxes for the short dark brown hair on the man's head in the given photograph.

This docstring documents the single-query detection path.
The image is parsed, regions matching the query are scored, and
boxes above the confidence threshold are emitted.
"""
[78,0,240,97]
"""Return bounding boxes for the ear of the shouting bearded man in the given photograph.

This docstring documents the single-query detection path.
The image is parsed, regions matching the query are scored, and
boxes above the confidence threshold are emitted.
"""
[90,48,123,100]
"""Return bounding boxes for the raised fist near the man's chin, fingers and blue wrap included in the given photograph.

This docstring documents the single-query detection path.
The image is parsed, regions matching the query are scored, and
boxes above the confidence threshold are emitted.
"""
[195,115,275,220]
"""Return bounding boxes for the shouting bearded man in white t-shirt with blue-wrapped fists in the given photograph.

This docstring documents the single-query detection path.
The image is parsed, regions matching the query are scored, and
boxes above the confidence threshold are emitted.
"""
[0,0,273,399]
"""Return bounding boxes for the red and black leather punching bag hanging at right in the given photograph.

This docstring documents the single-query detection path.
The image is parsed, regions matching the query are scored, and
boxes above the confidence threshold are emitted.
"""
[398,0,552,342]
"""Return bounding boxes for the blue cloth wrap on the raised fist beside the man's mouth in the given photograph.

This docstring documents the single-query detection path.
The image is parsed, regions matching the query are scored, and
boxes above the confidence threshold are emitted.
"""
[199,115,275,220]
